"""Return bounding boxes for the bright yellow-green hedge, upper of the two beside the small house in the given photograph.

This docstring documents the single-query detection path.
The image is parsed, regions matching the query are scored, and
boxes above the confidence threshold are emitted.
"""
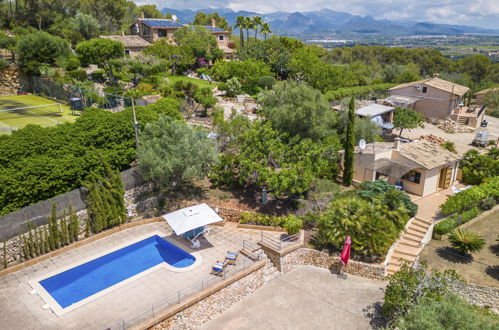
[440,177,499,214]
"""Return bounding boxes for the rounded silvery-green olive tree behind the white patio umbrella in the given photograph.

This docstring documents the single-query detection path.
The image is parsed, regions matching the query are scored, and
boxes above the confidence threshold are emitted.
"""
[138,116,218,188]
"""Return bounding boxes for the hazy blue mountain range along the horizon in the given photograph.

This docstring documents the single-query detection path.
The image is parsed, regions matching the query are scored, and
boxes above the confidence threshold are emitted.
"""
[162,8,499,36]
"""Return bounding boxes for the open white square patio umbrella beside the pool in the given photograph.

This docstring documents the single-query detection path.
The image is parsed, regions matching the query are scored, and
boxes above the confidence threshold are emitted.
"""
[163,203,223,235]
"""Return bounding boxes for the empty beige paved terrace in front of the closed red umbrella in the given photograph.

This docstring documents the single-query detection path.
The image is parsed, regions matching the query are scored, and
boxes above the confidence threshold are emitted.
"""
[201,266,386,330]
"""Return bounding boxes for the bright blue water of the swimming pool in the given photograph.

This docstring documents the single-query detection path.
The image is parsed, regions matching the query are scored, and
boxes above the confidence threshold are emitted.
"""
[40,235,196,308]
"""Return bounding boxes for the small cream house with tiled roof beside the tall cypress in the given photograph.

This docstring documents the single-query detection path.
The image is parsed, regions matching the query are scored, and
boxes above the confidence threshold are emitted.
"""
[340,138,461,196]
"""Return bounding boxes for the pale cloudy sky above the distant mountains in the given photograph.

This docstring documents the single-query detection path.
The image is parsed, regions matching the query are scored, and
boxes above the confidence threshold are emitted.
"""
[134,0,499,29]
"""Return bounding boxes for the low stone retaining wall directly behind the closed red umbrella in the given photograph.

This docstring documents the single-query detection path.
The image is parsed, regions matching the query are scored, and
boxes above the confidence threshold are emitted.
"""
[281,248,385,280]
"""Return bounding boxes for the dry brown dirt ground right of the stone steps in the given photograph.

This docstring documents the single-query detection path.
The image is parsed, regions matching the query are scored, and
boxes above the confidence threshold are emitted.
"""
[420,212,499,287]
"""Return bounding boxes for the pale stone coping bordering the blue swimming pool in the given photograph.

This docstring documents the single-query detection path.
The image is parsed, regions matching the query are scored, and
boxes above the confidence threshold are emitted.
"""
[28,230,203,317]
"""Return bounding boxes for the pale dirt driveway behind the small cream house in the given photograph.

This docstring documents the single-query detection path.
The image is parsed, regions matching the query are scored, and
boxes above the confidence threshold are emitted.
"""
[395,116,499,154]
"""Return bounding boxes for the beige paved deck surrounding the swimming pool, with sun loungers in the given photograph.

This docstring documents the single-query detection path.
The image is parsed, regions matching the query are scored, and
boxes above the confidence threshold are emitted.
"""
[0,223,270,329]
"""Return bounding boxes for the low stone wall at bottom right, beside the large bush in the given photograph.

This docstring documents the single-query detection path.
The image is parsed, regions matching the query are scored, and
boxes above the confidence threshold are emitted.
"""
[451,282,499,314]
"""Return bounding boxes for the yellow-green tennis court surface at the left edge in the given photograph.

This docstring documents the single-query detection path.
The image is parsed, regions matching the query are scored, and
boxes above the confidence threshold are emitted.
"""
[0,95,76,134]
